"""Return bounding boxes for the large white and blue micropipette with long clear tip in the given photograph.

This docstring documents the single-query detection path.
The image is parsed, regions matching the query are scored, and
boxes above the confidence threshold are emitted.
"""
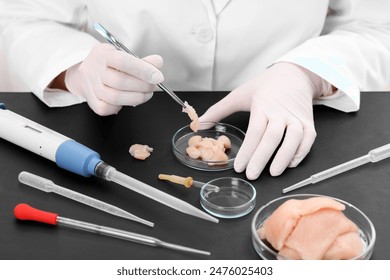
[0,103,218,223]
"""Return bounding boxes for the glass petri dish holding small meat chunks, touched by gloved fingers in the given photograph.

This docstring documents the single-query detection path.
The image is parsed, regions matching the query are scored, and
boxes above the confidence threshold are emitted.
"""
[172,122,245,171]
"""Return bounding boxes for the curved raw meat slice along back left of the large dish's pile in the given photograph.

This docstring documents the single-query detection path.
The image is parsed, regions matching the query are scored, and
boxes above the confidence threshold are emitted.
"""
[258,197,345,251]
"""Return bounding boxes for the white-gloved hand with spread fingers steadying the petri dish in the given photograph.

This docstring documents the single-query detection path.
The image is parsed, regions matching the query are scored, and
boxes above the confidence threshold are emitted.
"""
[199,62,332,180]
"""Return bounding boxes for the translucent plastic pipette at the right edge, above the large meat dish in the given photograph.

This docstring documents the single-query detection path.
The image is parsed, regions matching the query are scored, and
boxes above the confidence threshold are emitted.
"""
[283,144,390,193]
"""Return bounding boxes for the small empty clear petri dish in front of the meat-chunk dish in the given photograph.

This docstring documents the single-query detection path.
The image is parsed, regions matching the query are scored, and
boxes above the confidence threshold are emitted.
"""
[200,177,256,219]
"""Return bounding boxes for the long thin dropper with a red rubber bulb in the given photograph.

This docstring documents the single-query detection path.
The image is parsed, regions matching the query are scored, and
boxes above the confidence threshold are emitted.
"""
[14,203,210,255]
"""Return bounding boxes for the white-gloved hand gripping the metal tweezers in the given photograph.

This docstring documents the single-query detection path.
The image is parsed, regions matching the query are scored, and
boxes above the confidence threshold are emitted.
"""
[65,44,164,116]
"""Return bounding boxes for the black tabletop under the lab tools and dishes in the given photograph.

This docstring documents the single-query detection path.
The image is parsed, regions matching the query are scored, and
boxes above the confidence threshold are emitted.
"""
[0,92,390,260]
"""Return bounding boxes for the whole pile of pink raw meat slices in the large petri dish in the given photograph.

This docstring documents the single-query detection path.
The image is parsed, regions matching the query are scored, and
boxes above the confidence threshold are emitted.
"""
[258,197,363,260]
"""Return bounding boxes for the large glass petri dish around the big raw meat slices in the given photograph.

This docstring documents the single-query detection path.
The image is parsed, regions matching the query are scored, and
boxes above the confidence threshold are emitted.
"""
[251,194,376,260]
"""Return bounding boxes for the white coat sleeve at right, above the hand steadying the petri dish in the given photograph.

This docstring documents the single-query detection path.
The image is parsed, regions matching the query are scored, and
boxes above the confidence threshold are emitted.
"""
[278,0,390,112]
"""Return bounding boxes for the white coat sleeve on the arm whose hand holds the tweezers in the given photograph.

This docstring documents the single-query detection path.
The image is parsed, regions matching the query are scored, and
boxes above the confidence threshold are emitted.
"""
[0,0,97,106]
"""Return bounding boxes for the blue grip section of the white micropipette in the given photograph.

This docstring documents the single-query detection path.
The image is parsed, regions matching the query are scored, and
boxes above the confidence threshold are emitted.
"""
[56,139,102,177]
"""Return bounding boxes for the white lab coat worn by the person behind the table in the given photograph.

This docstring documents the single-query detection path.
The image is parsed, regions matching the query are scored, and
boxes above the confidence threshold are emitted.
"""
[0,0,390,112]
